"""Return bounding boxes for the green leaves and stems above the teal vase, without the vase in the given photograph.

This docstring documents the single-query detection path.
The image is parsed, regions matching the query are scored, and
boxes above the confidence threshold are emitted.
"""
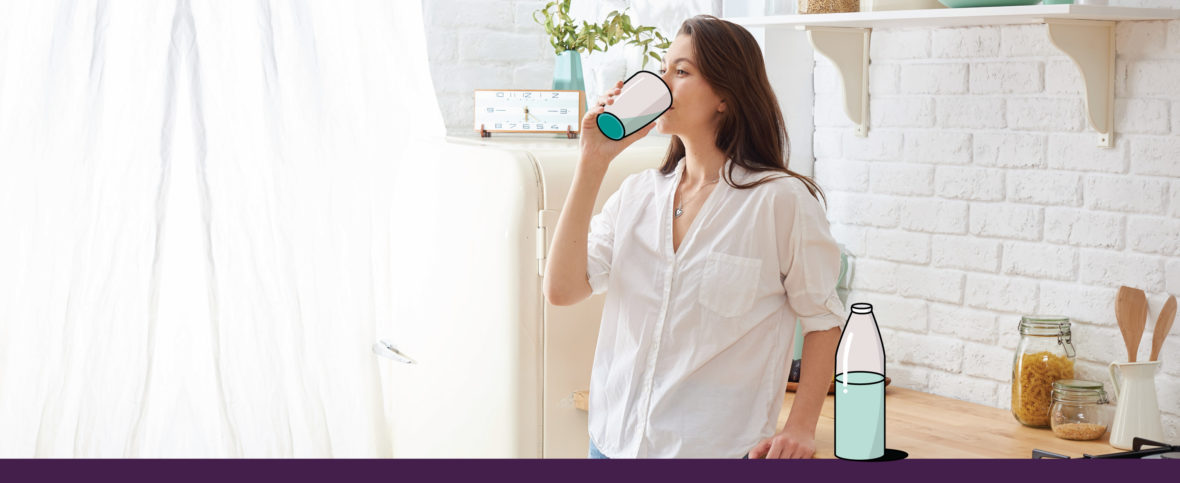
[532,0,671,68]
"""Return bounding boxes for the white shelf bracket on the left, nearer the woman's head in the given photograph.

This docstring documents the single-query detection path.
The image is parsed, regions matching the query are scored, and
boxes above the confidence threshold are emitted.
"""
[806,26,873,137]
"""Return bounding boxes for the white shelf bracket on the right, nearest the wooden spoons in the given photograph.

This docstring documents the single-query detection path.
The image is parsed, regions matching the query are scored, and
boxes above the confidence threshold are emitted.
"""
[1044,19,1115,148]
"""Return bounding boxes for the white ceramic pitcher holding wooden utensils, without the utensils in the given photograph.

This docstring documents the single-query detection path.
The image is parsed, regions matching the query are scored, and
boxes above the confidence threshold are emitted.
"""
[1109,360,1163,450]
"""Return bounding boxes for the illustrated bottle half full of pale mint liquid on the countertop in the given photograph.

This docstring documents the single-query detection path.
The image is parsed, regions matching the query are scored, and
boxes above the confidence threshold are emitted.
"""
[835,303,885,461]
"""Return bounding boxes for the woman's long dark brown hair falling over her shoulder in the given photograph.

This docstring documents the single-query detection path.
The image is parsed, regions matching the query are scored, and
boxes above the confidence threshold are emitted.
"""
[660,15,826,201]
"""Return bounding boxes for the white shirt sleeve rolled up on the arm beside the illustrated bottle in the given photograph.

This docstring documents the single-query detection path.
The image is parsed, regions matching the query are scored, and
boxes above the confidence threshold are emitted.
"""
[774,180,845,333]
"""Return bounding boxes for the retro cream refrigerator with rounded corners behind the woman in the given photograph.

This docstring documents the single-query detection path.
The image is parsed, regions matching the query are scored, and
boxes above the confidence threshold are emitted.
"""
[372,136,669,458]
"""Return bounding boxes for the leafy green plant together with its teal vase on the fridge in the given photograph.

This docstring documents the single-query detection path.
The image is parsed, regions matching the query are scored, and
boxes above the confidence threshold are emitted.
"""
[532,0,671,109]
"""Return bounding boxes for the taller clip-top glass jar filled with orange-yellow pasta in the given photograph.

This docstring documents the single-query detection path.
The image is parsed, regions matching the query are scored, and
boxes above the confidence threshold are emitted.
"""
[1012,315,1076,427]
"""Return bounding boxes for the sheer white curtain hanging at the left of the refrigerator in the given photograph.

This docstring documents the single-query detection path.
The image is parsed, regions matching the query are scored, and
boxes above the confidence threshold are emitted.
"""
[0,0,445,457]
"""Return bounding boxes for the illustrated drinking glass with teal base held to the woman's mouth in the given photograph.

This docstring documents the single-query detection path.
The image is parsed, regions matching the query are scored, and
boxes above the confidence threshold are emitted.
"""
[595,71,671,141]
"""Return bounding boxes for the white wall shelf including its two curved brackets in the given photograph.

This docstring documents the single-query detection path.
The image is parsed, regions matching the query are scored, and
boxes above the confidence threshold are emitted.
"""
[727,5,1180,148]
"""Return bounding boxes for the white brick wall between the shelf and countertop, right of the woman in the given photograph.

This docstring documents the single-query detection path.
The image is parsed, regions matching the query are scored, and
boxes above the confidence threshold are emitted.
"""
[815,17,1180,432]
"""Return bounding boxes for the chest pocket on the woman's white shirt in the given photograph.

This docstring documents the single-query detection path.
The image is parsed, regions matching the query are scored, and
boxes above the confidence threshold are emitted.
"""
[699,252,762,316]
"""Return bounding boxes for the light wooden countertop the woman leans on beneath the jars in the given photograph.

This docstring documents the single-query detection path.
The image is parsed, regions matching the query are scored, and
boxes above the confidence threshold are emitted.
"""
[575,386,1122,459]
